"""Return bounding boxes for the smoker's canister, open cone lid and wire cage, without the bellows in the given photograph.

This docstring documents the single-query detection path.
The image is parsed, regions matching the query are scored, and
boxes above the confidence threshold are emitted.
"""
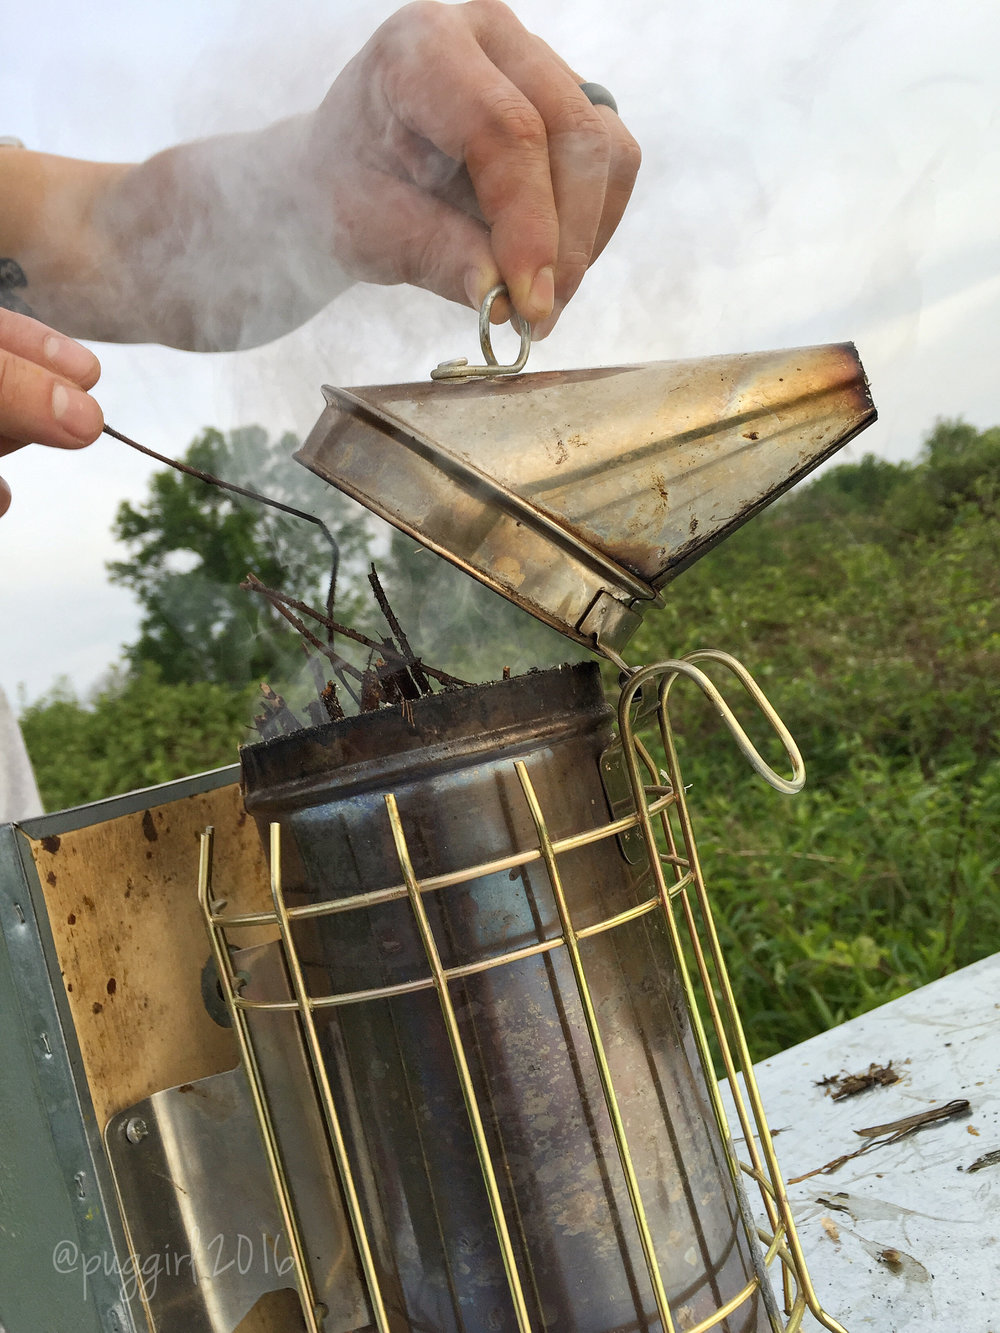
[193,335,873,1333]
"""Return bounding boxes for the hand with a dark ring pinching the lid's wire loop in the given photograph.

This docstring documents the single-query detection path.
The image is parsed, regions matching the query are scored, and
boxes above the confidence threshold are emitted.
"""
[303,0,640,336]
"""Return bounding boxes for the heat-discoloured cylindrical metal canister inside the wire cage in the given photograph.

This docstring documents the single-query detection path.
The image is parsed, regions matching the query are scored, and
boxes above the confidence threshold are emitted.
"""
[243,663,771,1333]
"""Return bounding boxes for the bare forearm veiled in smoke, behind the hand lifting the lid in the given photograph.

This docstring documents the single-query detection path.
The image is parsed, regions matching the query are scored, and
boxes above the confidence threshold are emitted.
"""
[0,119,349,351]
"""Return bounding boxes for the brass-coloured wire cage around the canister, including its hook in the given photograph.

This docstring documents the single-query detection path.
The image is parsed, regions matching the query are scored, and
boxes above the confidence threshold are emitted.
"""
[199,651,845,1333]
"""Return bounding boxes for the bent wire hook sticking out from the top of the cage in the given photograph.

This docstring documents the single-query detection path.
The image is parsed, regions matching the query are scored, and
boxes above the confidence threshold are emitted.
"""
[619,648,805,796]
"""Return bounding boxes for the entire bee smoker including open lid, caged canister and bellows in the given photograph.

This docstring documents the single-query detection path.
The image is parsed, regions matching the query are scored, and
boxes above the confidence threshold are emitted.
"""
[0,325,875,1333]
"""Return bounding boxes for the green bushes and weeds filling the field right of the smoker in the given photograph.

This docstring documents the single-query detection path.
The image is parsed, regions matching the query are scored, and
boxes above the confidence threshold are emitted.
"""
[629,423,1000,1056]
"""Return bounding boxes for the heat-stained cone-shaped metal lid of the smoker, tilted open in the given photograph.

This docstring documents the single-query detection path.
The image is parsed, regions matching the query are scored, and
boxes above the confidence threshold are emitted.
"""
[296,343,876,651]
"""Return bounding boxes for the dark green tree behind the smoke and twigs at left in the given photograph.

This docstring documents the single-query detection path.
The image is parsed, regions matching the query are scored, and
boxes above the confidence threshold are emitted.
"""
[109,427,371,688]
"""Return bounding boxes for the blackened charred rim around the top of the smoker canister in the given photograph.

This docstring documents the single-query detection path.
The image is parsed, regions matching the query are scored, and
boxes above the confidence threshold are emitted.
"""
[240,661,613,814]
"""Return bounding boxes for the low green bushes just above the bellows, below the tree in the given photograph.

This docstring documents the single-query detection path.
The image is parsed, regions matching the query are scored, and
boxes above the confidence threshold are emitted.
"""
[20,665,253,810]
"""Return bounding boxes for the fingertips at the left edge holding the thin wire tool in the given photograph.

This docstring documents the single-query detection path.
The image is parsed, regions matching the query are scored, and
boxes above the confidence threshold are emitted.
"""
[0,308,104,515]
